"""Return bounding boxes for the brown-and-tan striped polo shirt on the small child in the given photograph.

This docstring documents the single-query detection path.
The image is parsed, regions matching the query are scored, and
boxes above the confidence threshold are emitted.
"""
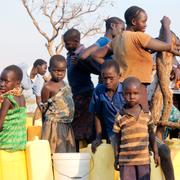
[113,110,153,165]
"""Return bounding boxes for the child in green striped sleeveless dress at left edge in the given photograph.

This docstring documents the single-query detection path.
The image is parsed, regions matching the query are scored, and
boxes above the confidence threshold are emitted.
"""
[0,65,26,152]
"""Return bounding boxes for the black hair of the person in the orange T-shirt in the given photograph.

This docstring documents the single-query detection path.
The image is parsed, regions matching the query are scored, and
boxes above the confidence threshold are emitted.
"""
[124,6,145,26]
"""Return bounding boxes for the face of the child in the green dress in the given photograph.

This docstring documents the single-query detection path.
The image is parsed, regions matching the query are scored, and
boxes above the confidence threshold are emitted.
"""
[0,70,20,92]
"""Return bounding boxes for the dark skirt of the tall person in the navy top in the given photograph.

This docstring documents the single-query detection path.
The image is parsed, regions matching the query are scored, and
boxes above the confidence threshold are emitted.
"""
[72,92,95,141]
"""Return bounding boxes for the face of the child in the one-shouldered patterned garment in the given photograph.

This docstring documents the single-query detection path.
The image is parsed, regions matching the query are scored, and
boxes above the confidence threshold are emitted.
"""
[50,62,66,82]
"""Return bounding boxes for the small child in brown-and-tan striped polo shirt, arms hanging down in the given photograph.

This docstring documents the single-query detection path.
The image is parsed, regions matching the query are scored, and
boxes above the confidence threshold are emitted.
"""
[113,77,160,180]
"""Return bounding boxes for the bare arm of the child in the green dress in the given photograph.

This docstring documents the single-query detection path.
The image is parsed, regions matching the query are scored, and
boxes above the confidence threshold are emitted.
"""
[0,98,11,131]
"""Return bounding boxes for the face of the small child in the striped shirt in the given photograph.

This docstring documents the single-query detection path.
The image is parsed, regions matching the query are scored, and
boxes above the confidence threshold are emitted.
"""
[123,84,140,107]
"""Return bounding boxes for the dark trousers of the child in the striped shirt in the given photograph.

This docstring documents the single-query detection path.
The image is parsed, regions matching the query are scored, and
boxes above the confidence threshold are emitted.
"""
[120,164,150,180]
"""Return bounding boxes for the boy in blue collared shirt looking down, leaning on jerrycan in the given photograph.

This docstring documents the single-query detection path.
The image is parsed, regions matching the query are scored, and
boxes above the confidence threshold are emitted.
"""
[89,60,123,152]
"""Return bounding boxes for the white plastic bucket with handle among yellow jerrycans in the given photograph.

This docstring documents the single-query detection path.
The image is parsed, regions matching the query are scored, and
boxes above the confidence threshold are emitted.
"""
[53,153,91,180]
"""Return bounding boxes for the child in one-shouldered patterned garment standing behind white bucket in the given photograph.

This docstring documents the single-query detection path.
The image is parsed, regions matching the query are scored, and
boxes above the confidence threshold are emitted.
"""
[41,55,76,153]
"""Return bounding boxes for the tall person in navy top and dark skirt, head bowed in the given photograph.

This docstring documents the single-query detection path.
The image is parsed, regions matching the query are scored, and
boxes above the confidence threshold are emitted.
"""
[63,29,94,151]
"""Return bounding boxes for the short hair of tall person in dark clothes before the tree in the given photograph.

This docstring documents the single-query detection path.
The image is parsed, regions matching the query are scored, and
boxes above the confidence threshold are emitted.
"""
[63,28,81,42]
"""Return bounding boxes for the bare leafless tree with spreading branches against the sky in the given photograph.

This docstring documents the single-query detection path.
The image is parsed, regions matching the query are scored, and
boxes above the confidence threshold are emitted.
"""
[21,0,111,56]
